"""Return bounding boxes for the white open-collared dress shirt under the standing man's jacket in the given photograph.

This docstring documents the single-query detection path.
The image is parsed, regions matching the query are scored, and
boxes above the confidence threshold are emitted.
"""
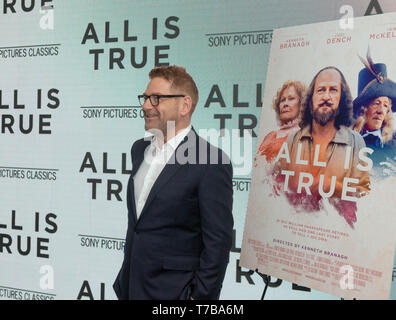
[133,125,191,219]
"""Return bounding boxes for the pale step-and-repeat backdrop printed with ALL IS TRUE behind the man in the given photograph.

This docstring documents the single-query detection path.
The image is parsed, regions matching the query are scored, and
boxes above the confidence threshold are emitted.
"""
[0,0,396,300]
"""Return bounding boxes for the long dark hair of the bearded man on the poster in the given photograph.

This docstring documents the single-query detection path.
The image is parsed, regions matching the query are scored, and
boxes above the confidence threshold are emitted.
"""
[300,66,353,129]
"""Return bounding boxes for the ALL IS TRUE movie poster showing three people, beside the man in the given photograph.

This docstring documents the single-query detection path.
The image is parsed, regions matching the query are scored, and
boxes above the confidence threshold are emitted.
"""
[240,13,396,299]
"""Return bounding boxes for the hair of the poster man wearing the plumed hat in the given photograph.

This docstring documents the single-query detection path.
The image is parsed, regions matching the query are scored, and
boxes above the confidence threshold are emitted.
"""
[353,97,394,143]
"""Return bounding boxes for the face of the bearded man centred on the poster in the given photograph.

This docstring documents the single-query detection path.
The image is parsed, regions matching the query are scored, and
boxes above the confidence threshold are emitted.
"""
[311,69,341,126]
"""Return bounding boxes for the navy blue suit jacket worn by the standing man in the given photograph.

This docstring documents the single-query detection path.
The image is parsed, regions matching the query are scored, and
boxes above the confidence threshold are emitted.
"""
[113,129,233,300]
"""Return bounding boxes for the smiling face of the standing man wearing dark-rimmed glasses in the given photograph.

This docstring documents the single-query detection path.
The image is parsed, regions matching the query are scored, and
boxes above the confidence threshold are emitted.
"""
[143,78,182,136]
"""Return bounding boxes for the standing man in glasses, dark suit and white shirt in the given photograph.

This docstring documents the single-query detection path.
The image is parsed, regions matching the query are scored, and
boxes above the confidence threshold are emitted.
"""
[113,66,233,300]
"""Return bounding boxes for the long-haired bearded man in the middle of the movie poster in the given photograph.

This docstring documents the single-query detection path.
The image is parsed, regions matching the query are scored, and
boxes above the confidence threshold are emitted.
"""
[276,67,372,227]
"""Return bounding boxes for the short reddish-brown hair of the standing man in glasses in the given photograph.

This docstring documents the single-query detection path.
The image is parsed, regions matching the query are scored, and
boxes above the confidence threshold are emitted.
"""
[149,65,198,113]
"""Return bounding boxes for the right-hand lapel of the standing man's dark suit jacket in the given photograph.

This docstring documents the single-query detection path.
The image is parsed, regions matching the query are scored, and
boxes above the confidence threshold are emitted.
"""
[139,129,197,221]
